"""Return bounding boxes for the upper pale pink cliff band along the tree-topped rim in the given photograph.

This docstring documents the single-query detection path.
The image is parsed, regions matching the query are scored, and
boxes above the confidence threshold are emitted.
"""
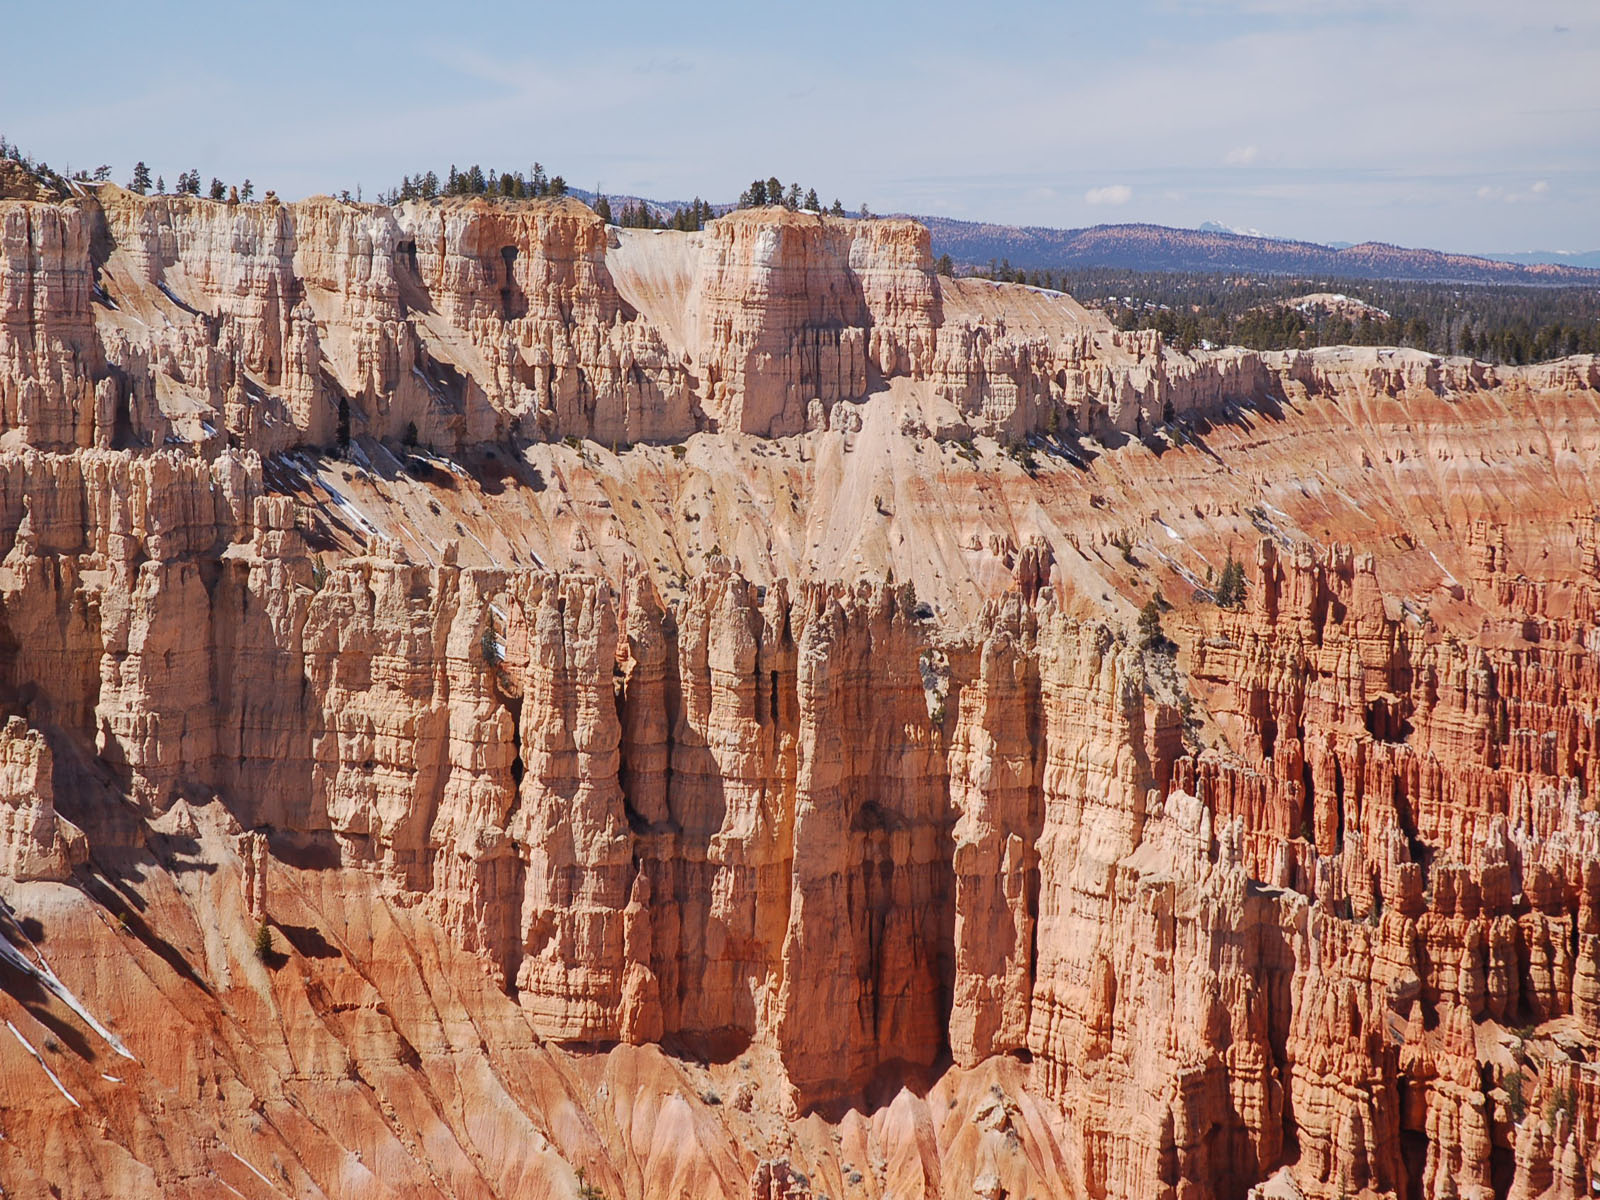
[9,186,1574,464]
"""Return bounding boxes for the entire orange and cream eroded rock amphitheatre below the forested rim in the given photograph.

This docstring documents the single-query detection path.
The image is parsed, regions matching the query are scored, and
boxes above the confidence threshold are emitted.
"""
[0,187,1600,1200]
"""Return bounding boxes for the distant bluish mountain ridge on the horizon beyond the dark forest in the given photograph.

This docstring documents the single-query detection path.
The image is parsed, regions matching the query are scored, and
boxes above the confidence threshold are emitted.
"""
[917,216,1600,286]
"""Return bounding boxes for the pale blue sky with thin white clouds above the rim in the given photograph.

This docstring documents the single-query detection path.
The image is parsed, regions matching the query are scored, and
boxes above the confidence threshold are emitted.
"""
[0,0,1600,253]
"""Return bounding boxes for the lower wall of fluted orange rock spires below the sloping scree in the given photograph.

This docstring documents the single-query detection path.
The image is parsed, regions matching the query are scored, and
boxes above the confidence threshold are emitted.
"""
[9,438,1600,1197]
